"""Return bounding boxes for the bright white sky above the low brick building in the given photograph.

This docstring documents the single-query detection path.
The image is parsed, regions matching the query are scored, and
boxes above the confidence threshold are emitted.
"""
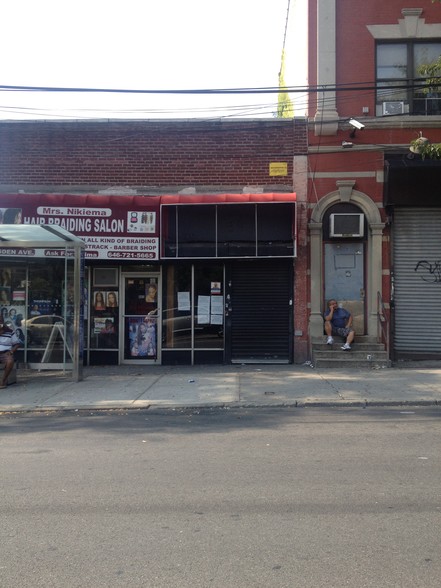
[0,0,307,120]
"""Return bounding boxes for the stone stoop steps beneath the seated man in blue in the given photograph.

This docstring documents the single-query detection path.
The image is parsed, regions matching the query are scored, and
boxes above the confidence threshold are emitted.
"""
[312,335,390,369]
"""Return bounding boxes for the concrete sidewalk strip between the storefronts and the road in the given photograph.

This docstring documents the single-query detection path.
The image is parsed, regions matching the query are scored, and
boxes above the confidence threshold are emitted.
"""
[0,362,441,412]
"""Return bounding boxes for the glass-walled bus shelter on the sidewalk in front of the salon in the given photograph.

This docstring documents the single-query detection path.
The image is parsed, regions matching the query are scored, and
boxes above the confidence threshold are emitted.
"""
[0,224,85,381]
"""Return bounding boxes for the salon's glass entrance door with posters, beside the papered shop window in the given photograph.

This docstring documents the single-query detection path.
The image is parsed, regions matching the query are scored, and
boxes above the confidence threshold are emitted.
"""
[121,274,160,363]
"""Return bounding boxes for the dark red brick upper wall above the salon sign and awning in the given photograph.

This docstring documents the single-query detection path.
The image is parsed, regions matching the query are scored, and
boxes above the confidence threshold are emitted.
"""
[0,119,306,189]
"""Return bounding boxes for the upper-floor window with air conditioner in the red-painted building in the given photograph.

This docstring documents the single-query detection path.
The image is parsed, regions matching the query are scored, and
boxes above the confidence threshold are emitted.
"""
[377,41,441,116]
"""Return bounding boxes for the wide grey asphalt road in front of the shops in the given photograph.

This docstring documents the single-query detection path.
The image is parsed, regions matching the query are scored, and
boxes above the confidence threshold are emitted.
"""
[0,408,441,588]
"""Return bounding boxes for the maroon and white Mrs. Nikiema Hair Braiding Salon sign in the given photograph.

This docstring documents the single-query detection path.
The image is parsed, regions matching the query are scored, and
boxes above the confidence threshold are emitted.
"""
[0,194,160,261]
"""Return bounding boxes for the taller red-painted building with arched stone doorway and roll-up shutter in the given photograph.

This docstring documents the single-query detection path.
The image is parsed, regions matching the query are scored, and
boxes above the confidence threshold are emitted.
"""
[308,0,441,359]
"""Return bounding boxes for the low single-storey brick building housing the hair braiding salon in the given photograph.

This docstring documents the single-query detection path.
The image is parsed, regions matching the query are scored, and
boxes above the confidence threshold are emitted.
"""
[0,119,308,364]
